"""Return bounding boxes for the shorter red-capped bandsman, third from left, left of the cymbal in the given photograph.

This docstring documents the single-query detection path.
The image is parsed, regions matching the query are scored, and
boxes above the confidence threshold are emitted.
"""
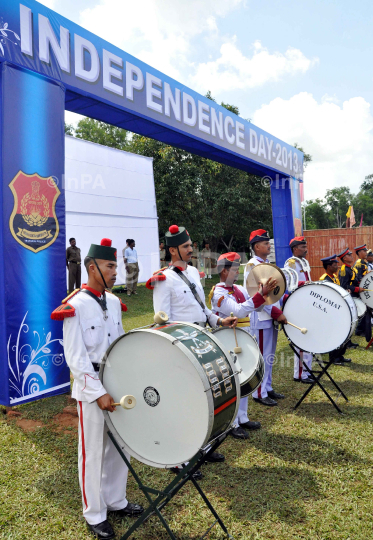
[210,252,277,439]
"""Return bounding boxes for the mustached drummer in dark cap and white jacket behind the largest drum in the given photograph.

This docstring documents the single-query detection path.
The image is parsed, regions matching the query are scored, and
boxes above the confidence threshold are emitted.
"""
[146,225,237,478]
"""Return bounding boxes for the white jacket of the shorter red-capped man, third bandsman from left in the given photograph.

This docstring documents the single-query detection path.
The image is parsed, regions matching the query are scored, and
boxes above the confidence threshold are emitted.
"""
[211,283,264,319]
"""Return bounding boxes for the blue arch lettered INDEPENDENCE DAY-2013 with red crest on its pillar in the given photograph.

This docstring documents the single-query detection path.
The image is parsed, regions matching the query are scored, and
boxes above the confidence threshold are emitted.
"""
[0,0,303,405]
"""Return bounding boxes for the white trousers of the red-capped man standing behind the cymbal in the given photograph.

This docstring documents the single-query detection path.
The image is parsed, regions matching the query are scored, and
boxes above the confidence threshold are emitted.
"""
[250,325,278,399]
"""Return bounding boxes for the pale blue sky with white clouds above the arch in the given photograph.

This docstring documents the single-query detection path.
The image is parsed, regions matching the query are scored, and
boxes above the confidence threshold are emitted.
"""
[42,0,373,199]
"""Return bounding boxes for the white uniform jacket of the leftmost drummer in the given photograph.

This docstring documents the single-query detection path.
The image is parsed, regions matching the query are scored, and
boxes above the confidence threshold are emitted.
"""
[63,292,124,403]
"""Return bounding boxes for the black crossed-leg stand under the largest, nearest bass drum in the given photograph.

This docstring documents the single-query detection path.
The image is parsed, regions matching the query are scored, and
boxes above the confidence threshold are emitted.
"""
[108,430,234,540]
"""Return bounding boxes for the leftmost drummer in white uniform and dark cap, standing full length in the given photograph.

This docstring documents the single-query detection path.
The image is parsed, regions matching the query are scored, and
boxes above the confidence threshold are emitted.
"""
[51,238,143,540]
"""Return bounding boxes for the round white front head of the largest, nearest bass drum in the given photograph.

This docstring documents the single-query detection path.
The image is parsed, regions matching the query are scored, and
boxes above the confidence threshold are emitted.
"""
[100,331,211,467]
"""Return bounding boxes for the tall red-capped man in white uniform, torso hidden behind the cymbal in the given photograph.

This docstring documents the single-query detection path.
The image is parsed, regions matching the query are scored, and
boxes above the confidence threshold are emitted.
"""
[244,229,287,407]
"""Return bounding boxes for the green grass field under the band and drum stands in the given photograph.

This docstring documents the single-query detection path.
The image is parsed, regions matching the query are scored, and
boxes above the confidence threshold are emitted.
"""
[0,279,373,540]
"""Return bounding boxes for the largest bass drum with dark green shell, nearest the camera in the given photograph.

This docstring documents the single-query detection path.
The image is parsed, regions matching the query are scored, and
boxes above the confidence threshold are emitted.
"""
[100,322,240,468]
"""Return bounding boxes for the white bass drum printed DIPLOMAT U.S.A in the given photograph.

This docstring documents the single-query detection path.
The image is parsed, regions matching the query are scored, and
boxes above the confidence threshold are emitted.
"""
[283,281,358,354]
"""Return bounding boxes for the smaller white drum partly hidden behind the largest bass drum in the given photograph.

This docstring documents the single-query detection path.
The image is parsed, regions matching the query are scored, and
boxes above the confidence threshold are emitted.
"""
[213,327,264,397]
